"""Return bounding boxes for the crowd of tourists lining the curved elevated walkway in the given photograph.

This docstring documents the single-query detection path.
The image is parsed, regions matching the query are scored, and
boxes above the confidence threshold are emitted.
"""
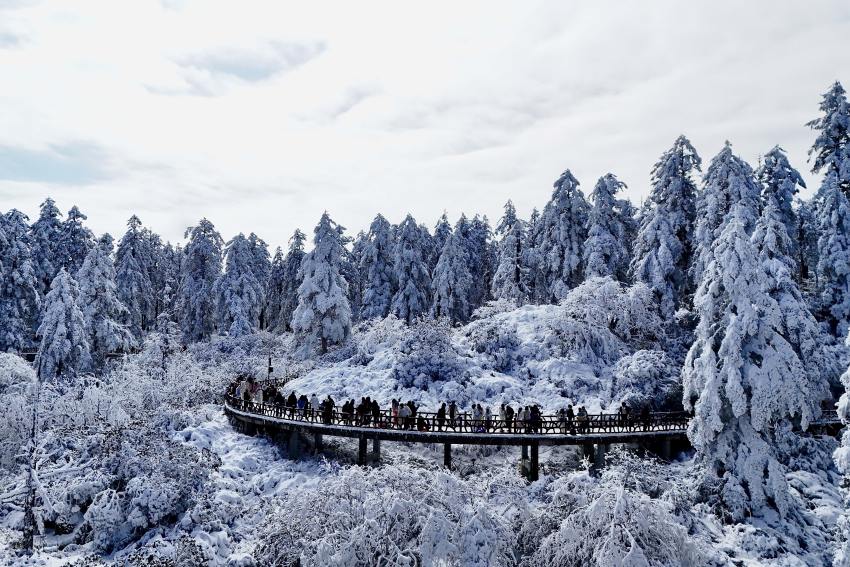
[228,377,653,435]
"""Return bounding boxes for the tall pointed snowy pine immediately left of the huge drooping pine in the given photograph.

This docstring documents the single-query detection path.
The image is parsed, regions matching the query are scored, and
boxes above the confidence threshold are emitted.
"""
[630,136,702,318]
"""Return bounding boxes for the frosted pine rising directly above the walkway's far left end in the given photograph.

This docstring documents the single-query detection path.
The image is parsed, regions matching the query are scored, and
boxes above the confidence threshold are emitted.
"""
[213,233,264,337]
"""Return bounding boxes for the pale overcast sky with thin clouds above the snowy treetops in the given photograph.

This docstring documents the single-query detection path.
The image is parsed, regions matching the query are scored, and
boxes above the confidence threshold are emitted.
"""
[0,0,850,246]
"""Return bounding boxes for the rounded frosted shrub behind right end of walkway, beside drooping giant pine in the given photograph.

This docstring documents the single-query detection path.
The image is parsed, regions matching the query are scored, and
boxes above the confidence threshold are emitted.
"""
[611,350,682,408]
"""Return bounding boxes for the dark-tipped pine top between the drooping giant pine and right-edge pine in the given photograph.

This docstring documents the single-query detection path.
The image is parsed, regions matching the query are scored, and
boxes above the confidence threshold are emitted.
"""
[756,146,806,262]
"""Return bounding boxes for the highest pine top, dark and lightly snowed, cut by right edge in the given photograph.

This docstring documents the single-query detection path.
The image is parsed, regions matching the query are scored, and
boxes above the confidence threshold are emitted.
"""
[806,81,850,197]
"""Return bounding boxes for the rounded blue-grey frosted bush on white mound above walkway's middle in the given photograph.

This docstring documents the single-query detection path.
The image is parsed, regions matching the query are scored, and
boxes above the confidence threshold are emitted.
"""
[393,321,464,390]
